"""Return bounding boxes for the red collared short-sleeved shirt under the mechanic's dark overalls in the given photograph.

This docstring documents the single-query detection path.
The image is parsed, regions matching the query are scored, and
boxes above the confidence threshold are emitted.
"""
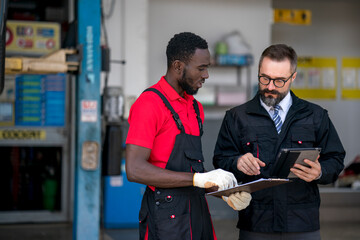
[126,77,204,168]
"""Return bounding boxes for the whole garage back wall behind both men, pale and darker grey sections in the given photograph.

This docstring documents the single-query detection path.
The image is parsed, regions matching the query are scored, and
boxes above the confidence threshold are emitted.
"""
[103,0,360,167]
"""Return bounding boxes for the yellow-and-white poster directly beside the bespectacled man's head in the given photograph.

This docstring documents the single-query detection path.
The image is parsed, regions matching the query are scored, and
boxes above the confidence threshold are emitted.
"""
[292,56,337,99]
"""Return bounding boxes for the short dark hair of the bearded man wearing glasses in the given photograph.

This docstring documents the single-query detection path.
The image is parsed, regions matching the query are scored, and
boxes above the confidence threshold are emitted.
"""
[259,44,297,72]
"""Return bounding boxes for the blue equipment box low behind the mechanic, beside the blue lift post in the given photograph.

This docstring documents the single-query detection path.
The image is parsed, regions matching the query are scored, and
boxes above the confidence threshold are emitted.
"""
[103,163,146,228]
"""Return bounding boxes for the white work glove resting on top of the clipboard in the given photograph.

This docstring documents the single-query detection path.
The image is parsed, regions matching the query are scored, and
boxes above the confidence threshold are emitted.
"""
[193,169,237,191]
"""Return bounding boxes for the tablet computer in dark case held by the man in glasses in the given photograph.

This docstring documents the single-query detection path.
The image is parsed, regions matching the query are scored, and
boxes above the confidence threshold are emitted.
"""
[272,148,321,178]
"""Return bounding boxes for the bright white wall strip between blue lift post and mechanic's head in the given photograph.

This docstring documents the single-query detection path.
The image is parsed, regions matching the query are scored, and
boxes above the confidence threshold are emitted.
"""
[102,0,149,117]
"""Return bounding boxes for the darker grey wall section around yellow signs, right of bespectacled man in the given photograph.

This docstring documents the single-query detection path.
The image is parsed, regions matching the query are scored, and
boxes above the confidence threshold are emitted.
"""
[271,0,360,168]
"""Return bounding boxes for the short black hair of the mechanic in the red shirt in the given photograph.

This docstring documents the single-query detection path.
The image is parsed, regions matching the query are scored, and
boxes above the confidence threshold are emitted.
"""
[166,32,208,68]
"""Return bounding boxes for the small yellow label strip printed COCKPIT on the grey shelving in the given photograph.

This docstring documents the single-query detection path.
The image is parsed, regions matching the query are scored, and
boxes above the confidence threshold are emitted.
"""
[0,129,46,140]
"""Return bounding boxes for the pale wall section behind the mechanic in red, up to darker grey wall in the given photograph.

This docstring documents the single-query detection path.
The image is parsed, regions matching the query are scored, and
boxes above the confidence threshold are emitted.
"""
[103,0,272,162]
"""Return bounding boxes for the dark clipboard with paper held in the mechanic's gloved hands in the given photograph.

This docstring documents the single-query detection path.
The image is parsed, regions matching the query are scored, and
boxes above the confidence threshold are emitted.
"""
[206,178,290,198]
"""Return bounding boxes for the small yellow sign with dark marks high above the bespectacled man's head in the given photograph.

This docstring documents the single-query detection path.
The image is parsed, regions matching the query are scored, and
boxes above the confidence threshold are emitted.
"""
[274,9,311,25]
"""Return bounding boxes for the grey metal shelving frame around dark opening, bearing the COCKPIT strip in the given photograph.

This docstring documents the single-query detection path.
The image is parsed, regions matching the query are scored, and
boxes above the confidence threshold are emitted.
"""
[0,75,74,223]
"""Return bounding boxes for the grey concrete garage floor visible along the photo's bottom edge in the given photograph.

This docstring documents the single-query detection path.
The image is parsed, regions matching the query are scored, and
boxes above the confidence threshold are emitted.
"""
[0,219,360,240]
